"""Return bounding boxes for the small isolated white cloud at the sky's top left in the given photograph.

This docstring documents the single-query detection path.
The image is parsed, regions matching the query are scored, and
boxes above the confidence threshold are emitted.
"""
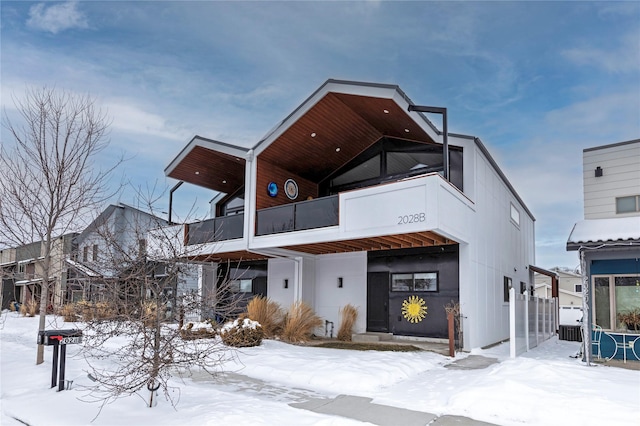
[27,1,89,34]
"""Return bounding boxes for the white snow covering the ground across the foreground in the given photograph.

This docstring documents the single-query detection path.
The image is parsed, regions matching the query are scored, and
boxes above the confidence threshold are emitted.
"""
[0,312,640,426]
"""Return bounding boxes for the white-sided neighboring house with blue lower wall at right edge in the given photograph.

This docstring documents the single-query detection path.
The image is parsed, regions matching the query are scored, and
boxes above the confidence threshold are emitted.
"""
[567,139,640,358]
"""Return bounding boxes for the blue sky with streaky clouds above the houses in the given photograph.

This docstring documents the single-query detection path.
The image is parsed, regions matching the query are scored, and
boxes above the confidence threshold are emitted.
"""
[0,0,640,268]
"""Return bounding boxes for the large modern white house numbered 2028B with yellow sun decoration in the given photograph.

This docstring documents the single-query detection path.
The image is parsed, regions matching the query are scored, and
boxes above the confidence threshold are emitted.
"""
[165,80,535,349]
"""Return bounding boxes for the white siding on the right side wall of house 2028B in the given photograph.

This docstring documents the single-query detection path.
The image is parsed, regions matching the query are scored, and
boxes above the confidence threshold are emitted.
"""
[460,143,535,349]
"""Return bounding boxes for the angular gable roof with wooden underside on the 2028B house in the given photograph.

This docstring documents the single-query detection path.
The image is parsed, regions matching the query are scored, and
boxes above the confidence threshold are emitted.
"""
[165,79,535,220]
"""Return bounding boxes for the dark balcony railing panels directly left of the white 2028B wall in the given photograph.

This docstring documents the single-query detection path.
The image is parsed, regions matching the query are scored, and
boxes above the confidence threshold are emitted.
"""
[256,195,339,235]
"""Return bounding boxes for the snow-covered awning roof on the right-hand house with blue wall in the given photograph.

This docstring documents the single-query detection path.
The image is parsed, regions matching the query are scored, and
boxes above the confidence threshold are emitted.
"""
[567,216,640,250]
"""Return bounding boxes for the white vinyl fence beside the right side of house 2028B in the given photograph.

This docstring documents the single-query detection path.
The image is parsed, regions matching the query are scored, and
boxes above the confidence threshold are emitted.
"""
[509,288,558,358]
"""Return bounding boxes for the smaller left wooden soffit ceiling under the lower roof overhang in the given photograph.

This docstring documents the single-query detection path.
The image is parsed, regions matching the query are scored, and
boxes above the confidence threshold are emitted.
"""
[167,145,245,194]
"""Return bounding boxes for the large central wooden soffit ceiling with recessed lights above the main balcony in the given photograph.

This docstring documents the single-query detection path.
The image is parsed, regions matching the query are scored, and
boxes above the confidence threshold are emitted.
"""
[258,93,433,183]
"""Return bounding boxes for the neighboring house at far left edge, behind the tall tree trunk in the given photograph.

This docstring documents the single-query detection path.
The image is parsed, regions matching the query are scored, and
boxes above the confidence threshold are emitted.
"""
[0,233,77,308]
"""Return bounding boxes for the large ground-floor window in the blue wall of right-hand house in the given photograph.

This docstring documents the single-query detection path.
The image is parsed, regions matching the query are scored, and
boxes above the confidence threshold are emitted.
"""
[593,275,640,330]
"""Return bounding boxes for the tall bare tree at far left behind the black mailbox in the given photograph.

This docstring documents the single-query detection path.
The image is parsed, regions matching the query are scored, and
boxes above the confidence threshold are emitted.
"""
[0,88,119,364]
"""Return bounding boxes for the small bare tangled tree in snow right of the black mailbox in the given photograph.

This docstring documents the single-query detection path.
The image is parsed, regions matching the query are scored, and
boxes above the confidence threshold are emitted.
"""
[73,190,245,406]
